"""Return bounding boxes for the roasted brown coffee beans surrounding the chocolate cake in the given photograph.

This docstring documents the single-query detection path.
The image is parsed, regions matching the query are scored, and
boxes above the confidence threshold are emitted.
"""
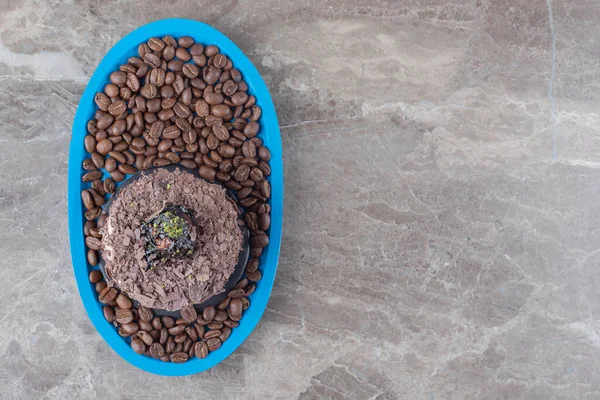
[81,36,271,363]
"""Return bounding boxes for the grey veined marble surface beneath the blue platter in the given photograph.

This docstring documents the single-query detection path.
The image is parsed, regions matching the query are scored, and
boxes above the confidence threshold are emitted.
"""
[0,0,600,400]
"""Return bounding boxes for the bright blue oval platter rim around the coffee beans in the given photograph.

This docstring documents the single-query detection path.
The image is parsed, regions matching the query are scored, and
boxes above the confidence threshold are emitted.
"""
[69,19,283,376]
